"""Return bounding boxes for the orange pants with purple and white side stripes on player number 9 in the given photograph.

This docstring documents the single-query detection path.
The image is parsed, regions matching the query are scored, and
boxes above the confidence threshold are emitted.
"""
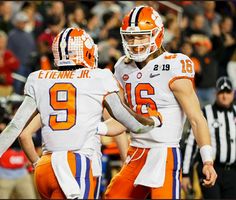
[35,152,96,199]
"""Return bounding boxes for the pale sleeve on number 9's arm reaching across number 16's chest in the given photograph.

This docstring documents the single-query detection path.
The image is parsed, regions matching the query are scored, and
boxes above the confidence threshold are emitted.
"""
[105,93,154,133]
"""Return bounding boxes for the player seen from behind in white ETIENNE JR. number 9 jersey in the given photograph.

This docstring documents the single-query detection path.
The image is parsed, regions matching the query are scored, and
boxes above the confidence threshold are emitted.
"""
[0,28,162,199]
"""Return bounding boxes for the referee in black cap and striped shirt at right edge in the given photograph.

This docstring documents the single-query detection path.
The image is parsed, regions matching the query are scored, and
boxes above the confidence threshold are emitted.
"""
[182,77,236,199]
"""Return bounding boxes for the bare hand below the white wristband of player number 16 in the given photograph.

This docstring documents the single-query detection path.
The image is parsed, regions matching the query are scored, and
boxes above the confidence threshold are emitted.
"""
[202,162,217,187]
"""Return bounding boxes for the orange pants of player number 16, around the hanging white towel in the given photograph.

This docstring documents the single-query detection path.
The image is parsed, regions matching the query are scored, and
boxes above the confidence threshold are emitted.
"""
[105,147,182,199]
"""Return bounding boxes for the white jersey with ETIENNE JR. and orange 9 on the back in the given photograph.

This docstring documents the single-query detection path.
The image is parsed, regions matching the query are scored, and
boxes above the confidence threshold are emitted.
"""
[25,68,119,151]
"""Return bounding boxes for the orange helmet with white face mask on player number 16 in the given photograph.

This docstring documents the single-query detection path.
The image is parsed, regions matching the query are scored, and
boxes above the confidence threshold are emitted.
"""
[120,6,164,62]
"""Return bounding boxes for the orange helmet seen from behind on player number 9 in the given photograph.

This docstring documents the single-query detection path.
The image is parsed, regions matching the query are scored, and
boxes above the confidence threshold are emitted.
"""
[52,28,98,68]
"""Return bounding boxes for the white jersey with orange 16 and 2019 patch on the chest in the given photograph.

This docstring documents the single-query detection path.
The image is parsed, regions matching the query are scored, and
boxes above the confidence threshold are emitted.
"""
[115,52,194,148]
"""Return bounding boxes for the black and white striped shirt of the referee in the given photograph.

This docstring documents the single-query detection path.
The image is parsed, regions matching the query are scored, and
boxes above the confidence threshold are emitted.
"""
[183,103,236,175]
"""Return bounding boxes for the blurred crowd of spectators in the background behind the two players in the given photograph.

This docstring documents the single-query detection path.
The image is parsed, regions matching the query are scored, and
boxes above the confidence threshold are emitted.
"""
[0,1,236,199]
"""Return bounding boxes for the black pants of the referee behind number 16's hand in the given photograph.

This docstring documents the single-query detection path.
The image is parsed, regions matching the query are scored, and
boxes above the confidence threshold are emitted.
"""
[197,164,236,199]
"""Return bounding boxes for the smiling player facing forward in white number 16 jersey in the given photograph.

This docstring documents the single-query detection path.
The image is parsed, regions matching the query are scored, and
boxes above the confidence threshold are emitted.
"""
[103,6,217,199]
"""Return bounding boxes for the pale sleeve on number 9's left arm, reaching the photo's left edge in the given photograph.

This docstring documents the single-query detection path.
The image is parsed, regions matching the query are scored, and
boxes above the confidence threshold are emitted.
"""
[0,96,37,157]
